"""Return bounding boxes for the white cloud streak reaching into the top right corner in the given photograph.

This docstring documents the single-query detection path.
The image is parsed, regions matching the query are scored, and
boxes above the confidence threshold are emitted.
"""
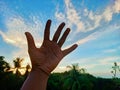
[85,0,120,28]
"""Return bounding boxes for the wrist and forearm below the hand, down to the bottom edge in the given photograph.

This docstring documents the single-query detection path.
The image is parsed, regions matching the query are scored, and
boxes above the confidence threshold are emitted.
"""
[21,69,49,90]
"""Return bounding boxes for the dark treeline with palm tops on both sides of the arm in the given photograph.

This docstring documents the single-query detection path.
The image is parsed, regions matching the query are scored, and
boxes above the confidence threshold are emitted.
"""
[0,56,120,90]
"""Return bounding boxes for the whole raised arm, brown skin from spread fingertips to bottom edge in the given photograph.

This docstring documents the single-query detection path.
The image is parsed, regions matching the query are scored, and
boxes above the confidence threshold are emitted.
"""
[21,20,77,90]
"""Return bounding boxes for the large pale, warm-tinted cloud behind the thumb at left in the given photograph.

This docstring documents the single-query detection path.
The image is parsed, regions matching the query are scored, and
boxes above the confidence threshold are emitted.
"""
[0,16,42,58]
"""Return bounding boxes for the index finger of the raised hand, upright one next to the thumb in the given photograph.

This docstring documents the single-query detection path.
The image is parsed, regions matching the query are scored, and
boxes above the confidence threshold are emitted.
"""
[44,20,51,40]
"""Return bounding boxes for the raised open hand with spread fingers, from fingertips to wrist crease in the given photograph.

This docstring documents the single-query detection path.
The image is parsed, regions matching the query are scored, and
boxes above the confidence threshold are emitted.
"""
[25,20,77,75]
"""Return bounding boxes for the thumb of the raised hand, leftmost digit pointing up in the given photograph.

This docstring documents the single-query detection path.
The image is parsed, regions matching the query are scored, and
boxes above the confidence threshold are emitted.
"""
[25,32,35,50]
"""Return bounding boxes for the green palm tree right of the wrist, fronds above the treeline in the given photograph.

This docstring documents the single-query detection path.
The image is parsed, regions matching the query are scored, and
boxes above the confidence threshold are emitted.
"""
[63,64,85,90]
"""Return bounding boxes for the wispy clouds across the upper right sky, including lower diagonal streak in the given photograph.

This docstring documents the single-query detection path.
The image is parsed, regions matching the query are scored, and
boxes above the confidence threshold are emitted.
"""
[55,0,120,48]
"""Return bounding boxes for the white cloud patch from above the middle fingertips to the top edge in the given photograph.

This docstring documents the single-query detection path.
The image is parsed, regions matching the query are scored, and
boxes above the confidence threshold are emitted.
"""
[55,0,84,32]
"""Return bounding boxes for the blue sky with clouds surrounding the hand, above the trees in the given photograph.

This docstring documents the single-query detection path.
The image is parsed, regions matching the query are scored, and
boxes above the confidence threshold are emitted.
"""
[0,0,120,77]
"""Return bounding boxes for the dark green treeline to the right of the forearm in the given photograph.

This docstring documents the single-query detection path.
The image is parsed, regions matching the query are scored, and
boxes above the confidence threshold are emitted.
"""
[47,71,120,90]
